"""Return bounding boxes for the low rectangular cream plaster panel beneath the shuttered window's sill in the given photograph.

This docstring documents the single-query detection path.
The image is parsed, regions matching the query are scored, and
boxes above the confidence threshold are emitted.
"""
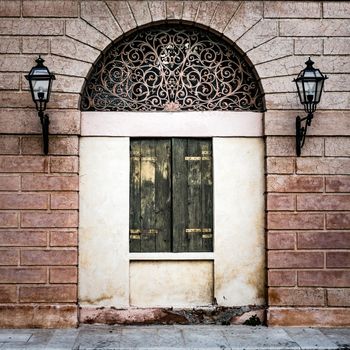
[130,261,213,308]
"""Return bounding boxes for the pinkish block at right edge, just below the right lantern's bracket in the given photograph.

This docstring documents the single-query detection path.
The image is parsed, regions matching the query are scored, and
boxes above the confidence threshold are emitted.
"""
[296,158,350,175]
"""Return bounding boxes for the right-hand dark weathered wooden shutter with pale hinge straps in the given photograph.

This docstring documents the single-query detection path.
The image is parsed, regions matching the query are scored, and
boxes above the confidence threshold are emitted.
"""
[172,138,213,252]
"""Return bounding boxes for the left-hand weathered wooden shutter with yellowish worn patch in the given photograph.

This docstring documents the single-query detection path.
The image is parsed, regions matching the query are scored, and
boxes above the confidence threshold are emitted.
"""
[130,139,171,252]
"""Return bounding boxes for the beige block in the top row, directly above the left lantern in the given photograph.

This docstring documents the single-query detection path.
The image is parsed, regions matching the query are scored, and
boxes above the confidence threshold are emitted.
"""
[23,0,78,17]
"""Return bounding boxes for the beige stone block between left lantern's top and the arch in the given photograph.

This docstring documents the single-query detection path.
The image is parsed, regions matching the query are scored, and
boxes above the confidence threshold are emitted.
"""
[45,56,91,78]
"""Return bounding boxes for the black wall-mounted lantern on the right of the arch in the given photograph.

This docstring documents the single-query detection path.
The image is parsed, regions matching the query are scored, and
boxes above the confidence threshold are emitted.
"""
[293,57,328,157]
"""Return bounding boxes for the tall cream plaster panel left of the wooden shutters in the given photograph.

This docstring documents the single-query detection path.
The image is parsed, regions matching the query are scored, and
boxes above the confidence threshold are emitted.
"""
[79,138,129,307]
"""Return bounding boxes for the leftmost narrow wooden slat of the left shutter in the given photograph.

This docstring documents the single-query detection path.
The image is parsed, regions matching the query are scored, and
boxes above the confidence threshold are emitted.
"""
[129,140,141,252]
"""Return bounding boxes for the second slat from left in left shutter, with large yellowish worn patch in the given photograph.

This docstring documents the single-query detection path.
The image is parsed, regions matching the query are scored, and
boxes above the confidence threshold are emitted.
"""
[140,139,156,252]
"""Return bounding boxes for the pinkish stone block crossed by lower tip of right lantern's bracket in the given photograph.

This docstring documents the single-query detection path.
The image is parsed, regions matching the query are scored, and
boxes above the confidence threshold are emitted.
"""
[266,136,324,156]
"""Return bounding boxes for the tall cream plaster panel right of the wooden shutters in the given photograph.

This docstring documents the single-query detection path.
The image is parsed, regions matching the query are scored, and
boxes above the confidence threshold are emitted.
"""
[213,138,265,306]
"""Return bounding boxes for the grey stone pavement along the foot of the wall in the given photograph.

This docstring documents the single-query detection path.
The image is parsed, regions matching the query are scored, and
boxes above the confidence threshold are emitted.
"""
[0,325,350,350]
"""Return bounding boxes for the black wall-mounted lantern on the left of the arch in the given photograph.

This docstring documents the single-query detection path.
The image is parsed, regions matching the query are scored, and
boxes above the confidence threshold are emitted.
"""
[26,56,55,154]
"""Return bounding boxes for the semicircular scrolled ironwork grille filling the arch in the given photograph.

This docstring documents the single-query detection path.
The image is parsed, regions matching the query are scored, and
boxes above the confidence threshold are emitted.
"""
[81,25,264,111]
